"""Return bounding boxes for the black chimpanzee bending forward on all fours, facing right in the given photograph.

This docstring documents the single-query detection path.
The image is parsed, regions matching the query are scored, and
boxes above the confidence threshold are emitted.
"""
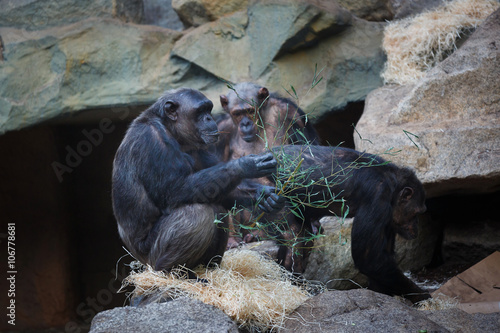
[273,146,430,302]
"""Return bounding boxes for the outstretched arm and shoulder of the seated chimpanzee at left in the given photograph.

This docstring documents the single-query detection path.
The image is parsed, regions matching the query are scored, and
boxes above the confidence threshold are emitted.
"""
[134,124,276,209]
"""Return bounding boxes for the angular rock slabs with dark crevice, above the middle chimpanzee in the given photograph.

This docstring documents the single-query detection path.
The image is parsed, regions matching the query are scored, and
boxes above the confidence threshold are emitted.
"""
[172,1,385,116]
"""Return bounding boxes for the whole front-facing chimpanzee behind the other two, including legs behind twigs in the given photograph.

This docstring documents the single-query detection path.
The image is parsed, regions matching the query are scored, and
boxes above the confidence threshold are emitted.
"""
[217,82,319,272]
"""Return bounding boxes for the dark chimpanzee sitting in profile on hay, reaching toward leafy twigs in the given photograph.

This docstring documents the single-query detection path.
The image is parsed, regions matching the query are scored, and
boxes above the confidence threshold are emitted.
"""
[112,88,282,270]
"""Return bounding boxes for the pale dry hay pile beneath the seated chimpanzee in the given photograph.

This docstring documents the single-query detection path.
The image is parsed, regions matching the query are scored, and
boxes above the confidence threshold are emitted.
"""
[124,250,311,331]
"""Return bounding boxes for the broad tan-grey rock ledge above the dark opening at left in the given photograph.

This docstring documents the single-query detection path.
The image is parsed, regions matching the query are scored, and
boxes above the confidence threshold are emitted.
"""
[0,18,189,133]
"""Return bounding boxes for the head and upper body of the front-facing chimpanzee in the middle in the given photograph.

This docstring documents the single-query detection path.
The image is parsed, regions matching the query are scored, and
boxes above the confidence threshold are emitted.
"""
[217,82,319,161]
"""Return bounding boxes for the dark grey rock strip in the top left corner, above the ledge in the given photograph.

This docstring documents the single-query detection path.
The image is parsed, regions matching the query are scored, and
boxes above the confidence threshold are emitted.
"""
[0,0,143,30]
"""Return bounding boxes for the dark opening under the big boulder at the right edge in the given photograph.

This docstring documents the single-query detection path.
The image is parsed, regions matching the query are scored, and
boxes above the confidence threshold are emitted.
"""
[414,192,500,291]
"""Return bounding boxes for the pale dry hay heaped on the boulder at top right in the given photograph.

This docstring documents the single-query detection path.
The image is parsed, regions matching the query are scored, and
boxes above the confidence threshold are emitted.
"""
[382,0,500,84]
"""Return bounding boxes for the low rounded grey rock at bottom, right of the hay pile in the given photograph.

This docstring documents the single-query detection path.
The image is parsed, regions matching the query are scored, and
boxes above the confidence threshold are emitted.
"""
[282,289,446,333]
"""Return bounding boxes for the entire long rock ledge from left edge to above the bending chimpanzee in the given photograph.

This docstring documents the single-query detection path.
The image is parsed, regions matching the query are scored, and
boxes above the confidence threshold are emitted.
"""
[0,0,385,133]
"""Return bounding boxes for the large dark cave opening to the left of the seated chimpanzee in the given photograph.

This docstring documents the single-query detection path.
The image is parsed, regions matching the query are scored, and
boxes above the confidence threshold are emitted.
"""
[0,118,133,331]
